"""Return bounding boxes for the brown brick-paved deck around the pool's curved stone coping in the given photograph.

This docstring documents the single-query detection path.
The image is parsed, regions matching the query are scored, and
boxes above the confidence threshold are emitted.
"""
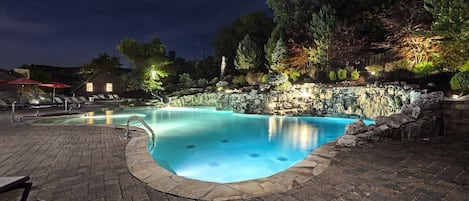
[0,111,469,201]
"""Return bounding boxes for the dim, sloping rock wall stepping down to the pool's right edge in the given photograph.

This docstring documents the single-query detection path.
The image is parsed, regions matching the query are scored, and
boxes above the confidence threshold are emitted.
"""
[337,92,444,146]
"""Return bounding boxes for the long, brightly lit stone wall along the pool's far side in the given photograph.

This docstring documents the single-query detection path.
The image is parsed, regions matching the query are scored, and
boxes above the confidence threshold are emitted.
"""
[171,84,421,118]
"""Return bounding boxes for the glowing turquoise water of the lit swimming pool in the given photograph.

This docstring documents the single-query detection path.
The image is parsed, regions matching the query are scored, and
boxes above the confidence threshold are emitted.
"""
[59,108,372,183]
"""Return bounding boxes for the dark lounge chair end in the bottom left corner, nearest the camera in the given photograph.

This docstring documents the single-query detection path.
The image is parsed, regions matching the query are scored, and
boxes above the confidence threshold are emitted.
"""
[0,176,33,201]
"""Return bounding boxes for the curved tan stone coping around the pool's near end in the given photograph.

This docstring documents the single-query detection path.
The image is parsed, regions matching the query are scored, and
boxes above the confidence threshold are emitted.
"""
[125,128,338,200]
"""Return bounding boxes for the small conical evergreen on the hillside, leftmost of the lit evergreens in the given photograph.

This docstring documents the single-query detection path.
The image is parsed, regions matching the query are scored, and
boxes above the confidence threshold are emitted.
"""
[235,35,260,71]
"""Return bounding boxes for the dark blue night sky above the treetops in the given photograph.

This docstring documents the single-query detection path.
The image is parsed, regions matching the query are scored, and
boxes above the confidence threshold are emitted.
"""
[0,0,271,69]
